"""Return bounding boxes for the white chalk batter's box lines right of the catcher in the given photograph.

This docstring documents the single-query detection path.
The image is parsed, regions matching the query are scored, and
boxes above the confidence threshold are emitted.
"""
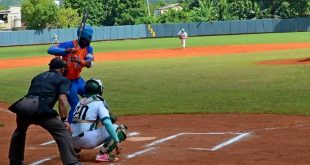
[127,132,251,159]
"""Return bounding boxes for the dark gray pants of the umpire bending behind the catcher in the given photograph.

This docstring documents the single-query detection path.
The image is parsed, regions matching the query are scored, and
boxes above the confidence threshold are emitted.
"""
[9,115,78,165]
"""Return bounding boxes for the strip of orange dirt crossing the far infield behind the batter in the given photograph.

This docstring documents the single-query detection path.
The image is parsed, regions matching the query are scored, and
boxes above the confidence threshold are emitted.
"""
[0,43,310,69]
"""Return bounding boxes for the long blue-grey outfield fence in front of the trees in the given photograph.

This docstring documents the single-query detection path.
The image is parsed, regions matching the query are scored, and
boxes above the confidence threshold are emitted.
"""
[0,18,310,46]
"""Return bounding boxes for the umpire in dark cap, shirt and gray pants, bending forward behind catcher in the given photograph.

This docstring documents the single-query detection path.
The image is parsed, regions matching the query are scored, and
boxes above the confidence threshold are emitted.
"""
[9,58,80,165]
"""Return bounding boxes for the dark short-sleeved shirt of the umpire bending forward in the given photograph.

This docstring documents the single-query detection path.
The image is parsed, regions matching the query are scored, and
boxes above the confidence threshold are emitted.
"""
[27,71,70,108]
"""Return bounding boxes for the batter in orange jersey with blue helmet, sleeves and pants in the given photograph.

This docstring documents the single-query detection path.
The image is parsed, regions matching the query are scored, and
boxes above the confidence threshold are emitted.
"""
[48,26,94,123]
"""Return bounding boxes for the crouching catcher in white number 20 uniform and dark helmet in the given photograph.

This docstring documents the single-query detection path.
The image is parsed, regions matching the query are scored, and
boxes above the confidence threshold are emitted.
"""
[70,78,127,162]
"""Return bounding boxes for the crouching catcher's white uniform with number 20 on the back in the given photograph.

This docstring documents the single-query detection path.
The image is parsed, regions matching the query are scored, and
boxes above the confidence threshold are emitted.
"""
[70,97,118,149]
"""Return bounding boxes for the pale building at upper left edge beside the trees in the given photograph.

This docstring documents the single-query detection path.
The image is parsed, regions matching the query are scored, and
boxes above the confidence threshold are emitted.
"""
[0,6,21,30]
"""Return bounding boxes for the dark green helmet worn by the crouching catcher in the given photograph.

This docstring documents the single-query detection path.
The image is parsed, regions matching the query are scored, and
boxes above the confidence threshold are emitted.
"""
[84,78,104,96]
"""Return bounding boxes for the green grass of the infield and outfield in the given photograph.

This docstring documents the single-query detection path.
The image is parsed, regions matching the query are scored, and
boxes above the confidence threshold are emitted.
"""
[0,33,310,115]
